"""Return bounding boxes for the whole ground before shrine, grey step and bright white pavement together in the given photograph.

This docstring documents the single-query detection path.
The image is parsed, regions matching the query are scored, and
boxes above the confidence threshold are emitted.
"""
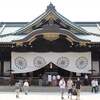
[0,86,100,100]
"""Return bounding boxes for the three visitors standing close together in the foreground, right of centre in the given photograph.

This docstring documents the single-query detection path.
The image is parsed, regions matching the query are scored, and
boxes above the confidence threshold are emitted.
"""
[59,77,81,100]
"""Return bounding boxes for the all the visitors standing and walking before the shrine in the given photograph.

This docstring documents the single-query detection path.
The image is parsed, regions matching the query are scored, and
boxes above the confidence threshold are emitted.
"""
[15,75,99,100]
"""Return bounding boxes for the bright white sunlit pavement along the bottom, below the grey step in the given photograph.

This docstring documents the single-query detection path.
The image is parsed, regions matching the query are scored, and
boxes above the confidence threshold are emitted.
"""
[0,92,100,100]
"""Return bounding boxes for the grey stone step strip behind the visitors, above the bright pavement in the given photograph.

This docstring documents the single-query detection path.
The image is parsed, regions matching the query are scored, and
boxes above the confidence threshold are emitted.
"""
[0,86,91,92]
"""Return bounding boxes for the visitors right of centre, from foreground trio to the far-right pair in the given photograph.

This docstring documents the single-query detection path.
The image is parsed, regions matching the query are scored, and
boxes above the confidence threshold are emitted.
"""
[59,76,99,100]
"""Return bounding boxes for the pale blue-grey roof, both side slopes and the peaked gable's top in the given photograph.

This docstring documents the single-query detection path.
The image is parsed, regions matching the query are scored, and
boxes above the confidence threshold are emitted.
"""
[0,4,100,42]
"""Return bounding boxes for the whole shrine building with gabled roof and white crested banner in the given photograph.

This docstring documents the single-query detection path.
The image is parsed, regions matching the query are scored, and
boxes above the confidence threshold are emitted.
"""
[0,3,100,84]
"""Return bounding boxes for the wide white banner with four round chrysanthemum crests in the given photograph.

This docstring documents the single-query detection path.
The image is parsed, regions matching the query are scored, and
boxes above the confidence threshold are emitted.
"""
[11,52,91,73]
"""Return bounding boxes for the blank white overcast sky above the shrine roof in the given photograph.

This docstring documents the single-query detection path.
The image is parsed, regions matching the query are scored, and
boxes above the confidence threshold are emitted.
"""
[0,0,100,22]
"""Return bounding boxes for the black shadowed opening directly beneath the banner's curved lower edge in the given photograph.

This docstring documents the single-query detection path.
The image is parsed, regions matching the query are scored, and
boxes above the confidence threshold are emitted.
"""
[14,63,76,78]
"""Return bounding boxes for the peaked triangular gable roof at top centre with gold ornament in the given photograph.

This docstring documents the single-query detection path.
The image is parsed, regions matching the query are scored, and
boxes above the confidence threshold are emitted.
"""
[16,3,89,34]
